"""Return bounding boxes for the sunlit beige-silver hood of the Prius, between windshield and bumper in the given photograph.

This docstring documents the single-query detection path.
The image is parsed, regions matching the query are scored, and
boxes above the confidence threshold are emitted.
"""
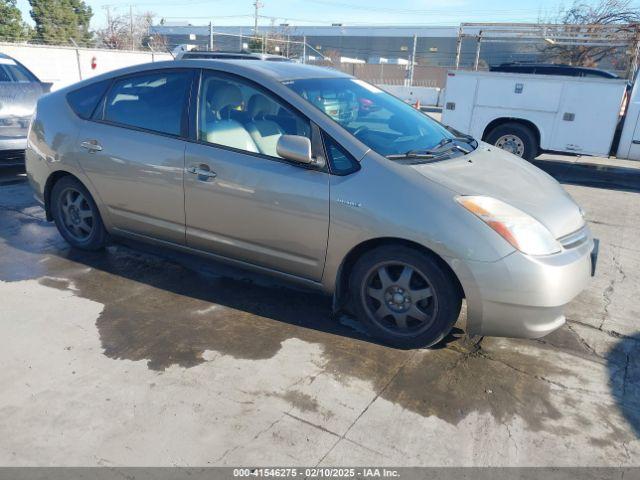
[411,143,584,238]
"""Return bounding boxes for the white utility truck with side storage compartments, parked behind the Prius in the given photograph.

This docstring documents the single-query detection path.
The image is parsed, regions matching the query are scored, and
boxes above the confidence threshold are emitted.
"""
[442,70,640,160]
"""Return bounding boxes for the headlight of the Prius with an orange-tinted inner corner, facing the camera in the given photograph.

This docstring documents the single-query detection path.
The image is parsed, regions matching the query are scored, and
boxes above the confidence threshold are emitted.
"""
[456,196,562,255]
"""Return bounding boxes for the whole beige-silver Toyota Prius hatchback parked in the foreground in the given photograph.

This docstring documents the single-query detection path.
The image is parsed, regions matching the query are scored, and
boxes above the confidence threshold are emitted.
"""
[26,60,597,348]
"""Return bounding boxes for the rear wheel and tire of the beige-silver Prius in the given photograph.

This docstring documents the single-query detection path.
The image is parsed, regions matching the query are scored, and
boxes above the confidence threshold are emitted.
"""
[51,176,108,251]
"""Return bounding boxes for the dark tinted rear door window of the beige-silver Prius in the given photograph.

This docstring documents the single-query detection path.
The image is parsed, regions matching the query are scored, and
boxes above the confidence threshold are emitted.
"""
[103,69,193,136]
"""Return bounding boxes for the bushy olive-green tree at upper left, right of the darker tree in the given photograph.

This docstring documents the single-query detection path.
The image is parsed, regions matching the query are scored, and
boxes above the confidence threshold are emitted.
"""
[29,0,93,45]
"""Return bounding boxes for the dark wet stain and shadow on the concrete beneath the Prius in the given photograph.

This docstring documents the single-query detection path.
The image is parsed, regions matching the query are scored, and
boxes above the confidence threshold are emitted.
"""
[0,181,620,434]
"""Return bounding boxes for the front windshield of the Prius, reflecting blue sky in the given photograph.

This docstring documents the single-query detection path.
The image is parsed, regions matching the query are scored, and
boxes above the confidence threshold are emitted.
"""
[284,78,454,156]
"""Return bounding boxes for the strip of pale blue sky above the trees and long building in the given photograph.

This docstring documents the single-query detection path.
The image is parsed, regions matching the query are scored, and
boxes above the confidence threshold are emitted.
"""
[13,0,640,28]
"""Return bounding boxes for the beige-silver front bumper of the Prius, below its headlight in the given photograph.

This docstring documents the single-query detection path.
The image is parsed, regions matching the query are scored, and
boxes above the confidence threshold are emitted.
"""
[451,233,598,338]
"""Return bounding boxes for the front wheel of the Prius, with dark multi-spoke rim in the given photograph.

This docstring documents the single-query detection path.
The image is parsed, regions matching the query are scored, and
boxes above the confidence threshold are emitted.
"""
[349,245,462,348]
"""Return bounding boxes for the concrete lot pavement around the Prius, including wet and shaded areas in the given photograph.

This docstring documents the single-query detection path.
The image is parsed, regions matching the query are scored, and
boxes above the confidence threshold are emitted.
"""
[0,159,640,466]
